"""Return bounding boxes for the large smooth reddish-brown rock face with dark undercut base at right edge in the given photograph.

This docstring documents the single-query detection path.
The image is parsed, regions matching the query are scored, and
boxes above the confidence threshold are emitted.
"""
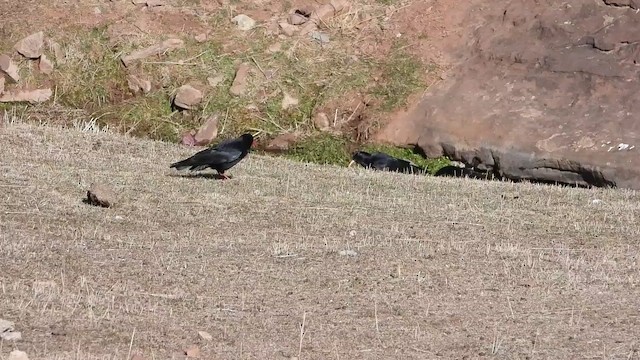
[377,0,640,189]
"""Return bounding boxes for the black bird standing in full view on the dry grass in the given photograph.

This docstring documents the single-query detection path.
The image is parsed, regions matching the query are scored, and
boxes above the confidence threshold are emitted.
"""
[170,134,253,179]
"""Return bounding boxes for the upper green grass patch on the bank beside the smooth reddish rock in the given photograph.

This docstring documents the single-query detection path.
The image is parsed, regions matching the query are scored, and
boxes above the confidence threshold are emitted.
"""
[371,42,426,111]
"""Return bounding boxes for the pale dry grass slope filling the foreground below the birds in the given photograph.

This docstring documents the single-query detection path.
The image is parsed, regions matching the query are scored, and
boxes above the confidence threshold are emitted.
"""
[0,124,640,359]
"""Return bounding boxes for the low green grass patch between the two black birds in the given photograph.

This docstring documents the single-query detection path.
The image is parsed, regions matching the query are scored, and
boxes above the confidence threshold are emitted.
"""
[285,133,351,165]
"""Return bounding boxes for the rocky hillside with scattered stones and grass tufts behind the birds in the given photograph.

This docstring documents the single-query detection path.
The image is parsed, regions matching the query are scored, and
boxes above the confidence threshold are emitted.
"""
[0,0,456,170]
